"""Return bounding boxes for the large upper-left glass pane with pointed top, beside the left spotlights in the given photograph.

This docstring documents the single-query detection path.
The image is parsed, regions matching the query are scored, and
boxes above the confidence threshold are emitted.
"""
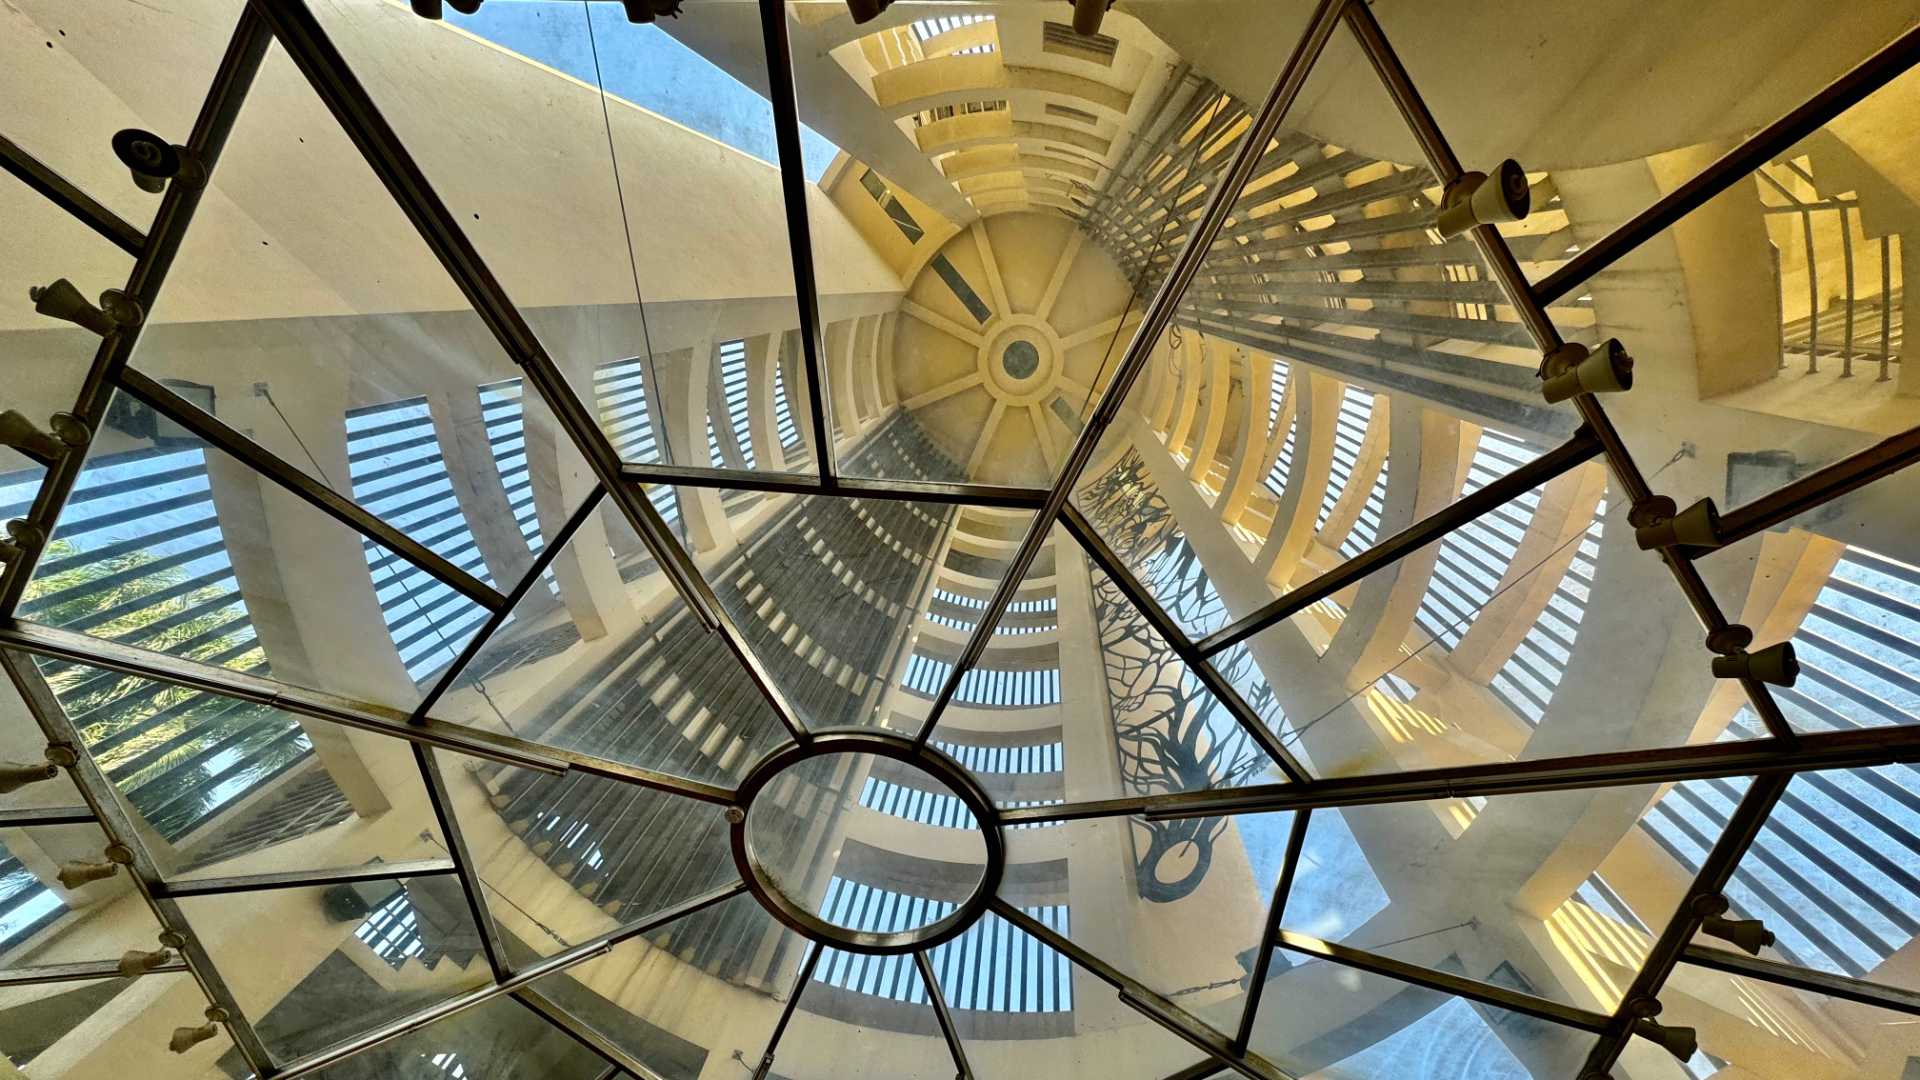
[130,37,591,568]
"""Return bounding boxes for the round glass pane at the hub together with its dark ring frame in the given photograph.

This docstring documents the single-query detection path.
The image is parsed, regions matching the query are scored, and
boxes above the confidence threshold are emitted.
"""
[728,728,1006,955]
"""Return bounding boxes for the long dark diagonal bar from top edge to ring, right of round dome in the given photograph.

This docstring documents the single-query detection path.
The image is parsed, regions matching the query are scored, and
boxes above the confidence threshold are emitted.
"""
[914,0,1348,744]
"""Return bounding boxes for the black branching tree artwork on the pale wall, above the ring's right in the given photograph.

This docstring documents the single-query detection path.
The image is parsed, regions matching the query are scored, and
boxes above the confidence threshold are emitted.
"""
[1077,452,1273,903]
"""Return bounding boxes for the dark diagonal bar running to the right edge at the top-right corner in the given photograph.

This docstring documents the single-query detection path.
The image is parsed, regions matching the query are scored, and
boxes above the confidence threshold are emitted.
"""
[1532,19,1920,304]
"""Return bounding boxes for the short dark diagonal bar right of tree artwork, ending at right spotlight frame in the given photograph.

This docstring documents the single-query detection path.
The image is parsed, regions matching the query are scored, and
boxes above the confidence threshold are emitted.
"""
[1198,427,1601,655]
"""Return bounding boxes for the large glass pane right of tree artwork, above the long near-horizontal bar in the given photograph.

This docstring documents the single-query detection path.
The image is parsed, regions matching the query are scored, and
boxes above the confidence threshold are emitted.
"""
[1210,486,1774,778]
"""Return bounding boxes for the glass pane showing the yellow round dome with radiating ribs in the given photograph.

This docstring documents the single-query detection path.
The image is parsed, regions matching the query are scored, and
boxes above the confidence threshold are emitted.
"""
[833,4,1328,484]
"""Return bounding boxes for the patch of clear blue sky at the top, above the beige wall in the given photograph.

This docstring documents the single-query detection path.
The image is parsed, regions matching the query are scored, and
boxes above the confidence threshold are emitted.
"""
[447,0,837,183]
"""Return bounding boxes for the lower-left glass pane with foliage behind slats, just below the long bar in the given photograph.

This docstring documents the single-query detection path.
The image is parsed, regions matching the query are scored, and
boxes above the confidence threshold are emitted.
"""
[20,661,445,880]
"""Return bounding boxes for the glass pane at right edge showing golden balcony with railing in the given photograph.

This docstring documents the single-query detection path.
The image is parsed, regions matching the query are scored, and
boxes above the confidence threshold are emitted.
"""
[1512,71,1920,526]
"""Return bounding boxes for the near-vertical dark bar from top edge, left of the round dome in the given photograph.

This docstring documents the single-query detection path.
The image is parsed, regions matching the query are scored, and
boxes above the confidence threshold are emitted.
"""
[760,0,837,484]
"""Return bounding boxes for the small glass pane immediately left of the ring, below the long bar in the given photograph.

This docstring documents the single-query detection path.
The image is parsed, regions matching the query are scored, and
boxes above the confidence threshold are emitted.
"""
[442,755,739,955]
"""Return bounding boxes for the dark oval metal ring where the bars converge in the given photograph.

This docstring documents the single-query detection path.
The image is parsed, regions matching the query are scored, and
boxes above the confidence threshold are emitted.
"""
[728,728,1006,955]
